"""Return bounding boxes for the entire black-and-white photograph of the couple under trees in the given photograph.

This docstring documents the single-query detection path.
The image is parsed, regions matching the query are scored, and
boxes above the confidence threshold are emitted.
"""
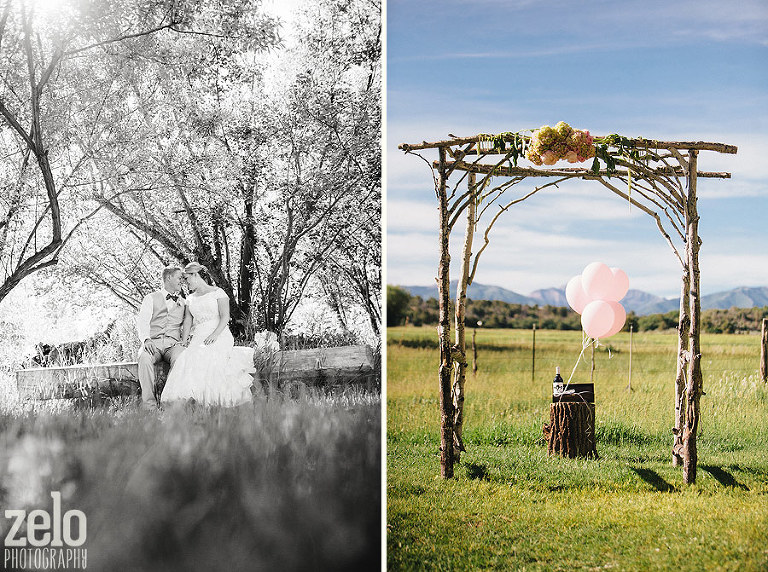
[0,0,384,571]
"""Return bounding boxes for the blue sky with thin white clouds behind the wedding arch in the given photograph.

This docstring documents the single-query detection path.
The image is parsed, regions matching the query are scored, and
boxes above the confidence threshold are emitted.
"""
[385,0,768,297]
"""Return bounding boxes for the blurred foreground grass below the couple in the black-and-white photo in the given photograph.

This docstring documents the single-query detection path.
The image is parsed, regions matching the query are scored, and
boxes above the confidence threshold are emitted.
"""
[0,378,381,572]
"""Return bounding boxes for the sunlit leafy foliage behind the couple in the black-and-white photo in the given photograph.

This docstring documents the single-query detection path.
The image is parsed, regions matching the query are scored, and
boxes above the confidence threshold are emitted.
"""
[0,0,381,342]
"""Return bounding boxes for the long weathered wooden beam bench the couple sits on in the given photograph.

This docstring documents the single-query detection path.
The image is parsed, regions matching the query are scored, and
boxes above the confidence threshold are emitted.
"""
[16,346,377,399]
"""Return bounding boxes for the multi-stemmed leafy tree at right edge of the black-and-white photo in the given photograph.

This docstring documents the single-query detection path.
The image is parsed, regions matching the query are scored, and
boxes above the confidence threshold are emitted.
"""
[249,0,381,332]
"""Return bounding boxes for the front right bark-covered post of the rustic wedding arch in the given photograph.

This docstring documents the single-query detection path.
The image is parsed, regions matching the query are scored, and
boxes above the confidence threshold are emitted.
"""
[683,149,703,485]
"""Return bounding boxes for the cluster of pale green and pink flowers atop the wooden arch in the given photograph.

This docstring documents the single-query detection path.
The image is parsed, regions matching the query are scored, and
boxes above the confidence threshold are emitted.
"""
[525,121,595,165]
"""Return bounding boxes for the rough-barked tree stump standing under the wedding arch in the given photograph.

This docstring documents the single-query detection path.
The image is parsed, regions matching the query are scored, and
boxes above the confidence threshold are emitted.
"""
[544,402,598,459]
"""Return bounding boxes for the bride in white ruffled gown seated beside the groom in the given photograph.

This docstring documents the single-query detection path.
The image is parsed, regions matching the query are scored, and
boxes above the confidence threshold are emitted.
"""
[161,262,255,406]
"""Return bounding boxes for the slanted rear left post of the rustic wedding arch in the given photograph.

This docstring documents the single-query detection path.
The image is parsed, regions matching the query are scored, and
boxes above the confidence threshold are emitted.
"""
[453,173,476,462]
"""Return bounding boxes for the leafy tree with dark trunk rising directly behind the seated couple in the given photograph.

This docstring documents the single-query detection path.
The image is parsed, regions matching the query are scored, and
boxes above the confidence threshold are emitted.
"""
[58,1,278,334]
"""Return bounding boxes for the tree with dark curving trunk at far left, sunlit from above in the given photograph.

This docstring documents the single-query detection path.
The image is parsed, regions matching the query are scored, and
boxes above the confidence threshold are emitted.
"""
[0,0,180,300]
